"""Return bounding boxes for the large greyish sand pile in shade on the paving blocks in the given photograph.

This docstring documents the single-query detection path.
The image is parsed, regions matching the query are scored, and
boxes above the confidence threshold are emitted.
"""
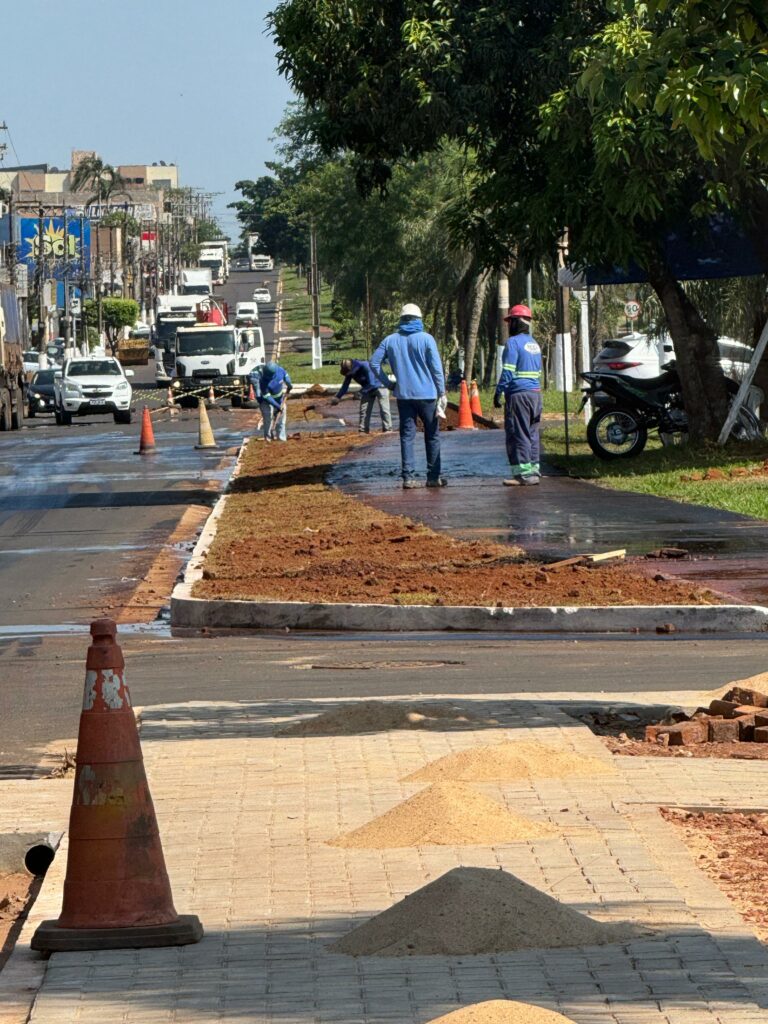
[331,867,641,956]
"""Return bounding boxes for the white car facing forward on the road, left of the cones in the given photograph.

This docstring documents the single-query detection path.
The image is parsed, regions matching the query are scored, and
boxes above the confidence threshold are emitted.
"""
[53,356,133,426]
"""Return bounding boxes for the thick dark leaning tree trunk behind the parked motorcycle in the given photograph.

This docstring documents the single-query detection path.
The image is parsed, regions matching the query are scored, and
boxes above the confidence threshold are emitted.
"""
[650,271,728,440]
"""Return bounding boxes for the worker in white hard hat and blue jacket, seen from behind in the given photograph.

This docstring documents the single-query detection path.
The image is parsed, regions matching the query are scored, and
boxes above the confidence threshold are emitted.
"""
[371,302,447,487]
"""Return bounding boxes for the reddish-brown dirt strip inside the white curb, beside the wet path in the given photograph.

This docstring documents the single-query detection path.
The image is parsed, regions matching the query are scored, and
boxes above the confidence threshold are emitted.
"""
[194,433,717,607]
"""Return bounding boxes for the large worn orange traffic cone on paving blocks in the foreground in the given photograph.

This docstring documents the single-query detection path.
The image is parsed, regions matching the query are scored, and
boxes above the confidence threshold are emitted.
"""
[32,618,203,952]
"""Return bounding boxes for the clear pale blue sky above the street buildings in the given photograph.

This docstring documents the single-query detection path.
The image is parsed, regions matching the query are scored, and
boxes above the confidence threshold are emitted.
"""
[0,0,291,236]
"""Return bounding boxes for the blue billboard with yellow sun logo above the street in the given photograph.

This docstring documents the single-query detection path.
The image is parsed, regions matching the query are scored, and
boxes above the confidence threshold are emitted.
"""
[16,214,91,279]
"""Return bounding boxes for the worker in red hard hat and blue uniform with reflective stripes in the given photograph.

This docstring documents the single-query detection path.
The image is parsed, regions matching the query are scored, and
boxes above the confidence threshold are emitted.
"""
[494,305,542,487]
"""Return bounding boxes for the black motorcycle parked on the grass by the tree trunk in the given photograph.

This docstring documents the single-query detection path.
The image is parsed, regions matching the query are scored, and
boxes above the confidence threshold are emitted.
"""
[581,362,763,459]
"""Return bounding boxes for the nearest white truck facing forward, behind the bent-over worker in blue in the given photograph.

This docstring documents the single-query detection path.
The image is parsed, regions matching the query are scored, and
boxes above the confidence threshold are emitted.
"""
[171,324,264,406]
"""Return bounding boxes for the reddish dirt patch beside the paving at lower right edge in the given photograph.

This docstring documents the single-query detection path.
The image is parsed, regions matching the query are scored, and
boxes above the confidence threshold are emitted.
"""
[662,808,768,942]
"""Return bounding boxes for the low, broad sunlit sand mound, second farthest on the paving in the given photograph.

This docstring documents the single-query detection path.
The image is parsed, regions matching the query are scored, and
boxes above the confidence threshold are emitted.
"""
[406,740,615,782]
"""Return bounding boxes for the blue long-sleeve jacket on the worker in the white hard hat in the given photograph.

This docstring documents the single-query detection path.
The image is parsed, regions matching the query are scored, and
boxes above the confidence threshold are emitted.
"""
[371,322,445,399]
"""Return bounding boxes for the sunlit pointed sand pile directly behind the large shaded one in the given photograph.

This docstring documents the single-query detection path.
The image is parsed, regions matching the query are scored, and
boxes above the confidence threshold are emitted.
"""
[331,782,556,850]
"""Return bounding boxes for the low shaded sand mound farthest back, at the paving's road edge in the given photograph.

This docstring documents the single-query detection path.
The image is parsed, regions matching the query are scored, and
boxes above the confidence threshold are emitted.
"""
[276,700,498,736]
